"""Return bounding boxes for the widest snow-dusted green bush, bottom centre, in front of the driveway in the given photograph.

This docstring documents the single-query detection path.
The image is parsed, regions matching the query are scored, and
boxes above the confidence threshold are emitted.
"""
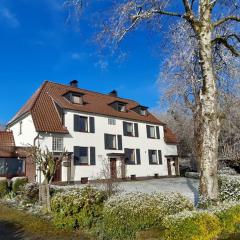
[103,193,193,239]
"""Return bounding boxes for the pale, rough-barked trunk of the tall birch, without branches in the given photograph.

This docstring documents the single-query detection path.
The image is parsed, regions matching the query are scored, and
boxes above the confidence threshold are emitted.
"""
[198,0,220,201]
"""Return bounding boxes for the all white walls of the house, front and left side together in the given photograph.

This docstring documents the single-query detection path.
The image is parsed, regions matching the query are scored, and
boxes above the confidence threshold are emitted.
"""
[10,110,177,181]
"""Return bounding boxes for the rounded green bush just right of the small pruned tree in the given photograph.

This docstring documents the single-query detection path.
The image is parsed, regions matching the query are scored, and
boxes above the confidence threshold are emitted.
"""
[51,187,107,229]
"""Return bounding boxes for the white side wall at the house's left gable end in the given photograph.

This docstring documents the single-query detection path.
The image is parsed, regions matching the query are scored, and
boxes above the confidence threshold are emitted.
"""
[9,114,37,147]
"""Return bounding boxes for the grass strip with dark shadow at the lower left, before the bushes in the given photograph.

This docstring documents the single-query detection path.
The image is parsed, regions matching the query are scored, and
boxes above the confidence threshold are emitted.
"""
[0,204,90,240]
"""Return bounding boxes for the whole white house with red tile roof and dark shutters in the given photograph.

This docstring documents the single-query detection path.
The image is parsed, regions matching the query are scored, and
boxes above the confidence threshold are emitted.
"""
[8,80,179,182]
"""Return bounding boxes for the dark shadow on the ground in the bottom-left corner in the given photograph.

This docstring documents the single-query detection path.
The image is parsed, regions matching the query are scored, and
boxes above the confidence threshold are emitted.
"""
[0,220,25,240]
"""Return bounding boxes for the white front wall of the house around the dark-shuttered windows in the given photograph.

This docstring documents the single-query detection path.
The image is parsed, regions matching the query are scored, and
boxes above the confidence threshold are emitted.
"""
[38,111,177,181]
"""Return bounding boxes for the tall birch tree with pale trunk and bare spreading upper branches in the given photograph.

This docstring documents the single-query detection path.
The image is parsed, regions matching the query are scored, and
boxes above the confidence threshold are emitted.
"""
[68,0,240,201]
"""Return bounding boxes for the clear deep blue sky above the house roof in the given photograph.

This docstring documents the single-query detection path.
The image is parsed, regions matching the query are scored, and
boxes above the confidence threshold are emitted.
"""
[0,0,172,123]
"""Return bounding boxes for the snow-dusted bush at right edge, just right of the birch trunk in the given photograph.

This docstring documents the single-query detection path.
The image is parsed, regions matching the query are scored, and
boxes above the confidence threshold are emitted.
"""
[218,175,240,201]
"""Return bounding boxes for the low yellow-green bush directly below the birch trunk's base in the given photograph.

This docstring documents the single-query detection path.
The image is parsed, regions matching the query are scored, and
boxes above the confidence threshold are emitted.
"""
[163,211,221,240]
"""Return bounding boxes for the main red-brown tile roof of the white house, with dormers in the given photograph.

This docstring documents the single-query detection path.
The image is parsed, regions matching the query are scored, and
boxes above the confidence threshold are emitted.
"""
[9,81,176,144]
